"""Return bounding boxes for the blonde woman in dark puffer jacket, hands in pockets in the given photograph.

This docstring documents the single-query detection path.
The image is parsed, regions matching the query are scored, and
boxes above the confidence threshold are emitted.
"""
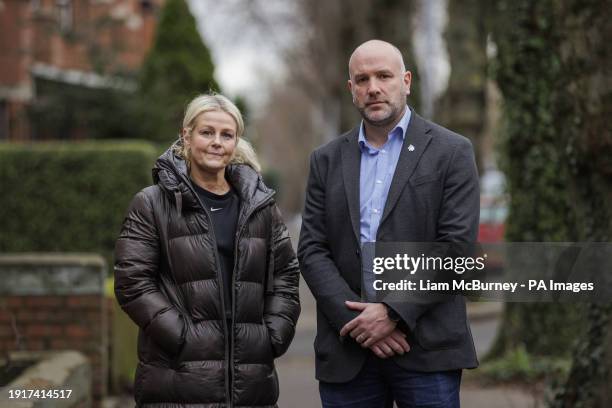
[115,95,300,408]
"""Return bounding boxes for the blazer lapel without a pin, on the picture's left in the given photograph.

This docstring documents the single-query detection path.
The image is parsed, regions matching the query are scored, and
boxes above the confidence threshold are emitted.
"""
[342,128,361,243]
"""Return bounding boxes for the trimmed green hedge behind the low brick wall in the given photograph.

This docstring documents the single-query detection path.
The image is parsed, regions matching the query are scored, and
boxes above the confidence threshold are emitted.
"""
[0,141,157,257]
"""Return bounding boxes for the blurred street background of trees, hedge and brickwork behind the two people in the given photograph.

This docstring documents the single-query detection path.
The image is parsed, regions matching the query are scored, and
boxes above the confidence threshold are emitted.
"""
[0,0,612,408]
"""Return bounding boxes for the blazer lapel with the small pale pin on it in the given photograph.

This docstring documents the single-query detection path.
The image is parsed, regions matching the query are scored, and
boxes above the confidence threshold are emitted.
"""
[378,110,431,231]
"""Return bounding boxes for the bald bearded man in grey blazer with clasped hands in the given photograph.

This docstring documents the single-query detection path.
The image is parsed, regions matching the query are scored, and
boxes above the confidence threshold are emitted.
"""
[298,40,479,408]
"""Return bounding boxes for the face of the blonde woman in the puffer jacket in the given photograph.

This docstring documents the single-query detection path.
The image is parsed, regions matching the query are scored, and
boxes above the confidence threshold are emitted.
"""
[183,111,238,175]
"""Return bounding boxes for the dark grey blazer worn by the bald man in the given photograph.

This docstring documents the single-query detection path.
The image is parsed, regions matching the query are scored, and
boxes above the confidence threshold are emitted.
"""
[298,111,480,382]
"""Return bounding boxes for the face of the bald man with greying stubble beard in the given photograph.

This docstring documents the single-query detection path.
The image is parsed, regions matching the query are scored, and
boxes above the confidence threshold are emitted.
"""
[348,47,411,127]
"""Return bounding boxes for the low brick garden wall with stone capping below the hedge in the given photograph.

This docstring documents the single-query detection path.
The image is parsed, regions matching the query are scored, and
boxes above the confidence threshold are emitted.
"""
[0,254,108,401]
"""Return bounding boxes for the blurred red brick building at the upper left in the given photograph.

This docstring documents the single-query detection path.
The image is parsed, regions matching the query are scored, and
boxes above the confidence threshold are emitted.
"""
[0,0,165,140]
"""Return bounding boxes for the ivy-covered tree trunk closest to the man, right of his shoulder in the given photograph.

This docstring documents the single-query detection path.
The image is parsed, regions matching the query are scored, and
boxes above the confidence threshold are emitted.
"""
[491,0,581,356]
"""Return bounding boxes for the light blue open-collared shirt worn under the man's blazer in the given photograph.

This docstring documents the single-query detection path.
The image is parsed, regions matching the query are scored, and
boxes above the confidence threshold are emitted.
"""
[358,106,411,244]
